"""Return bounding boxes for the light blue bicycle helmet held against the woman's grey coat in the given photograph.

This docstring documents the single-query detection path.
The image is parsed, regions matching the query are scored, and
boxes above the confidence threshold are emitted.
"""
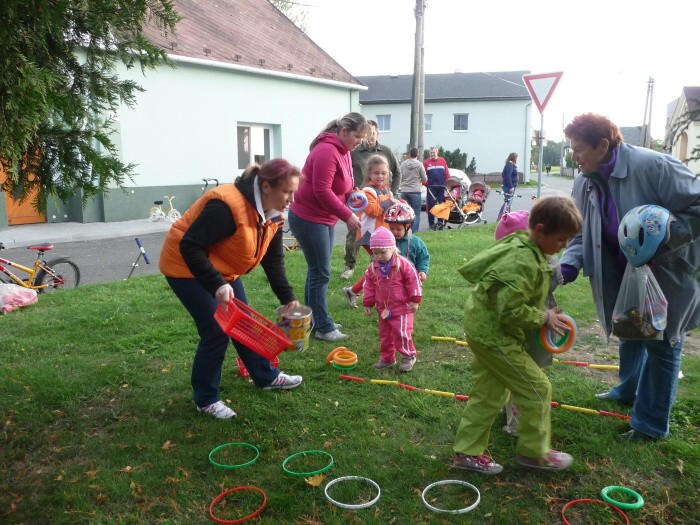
[617,204,671,266]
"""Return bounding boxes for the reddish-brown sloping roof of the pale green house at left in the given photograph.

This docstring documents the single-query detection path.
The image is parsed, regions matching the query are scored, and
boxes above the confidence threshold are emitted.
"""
[146,0,361,86]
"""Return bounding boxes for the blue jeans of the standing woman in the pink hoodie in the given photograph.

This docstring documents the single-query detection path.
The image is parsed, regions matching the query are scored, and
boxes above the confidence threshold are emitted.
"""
[288,211,335,333]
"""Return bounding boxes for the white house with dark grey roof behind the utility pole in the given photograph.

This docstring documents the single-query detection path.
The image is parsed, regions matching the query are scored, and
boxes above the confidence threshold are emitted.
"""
[357,71,532,177]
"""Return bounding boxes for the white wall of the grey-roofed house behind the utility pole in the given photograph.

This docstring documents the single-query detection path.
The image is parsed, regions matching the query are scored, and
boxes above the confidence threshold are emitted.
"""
[361,100,531,174]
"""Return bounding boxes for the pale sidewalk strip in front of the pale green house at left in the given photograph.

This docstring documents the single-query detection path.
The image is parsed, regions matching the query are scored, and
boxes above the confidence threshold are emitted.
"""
[0,219,170,249]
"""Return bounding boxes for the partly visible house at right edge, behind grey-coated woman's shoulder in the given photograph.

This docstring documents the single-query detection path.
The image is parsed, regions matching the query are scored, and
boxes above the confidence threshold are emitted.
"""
[665,86,700,174]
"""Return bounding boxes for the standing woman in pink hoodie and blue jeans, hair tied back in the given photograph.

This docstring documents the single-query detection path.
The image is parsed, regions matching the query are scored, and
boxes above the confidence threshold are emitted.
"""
[289,113,370,341]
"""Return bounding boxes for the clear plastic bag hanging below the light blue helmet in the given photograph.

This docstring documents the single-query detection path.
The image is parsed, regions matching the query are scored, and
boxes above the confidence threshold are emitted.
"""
[612,264,668,340]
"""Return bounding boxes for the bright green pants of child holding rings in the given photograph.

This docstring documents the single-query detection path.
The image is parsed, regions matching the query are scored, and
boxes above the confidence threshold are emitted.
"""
[454,341,552,458]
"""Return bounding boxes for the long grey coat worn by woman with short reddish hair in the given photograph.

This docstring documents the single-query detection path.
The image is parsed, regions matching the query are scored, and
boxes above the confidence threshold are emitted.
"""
[561,143,700,344]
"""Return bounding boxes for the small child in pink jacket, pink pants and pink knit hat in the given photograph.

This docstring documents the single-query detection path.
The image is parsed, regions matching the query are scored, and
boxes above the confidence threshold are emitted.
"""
[362,226,423,372]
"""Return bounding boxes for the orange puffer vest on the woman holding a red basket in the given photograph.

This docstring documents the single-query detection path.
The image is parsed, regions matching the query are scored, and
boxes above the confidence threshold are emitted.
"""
[158,184,282,281]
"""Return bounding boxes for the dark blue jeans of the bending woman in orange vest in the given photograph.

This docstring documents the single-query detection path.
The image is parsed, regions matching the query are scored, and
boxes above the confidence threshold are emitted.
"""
[166,277,280,408]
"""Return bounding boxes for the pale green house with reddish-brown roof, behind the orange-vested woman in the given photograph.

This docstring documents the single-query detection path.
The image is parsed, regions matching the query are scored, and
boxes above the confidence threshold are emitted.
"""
[0,0,366,226]
